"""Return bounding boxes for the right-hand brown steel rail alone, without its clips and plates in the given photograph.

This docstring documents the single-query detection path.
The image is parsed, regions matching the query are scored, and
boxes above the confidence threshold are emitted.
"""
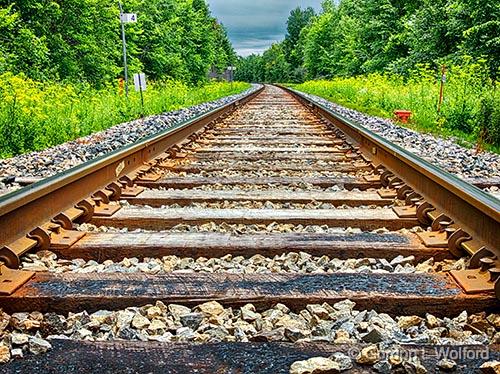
[280,86,500,258]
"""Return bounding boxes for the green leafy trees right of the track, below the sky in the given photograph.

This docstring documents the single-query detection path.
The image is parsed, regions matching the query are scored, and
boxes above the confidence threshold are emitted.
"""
[236,0,500,82]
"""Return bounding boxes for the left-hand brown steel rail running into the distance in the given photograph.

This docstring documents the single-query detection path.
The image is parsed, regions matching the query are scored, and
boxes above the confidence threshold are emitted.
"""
[0,86,264,248]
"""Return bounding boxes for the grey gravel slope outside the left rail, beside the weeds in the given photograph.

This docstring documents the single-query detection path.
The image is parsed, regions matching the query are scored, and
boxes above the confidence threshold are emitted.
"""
[0,85,260,181]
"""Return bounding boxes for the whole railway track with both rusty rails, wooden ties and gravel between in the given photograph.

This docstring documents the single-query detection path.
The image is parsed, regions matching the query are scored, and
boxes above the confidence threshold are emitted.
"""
[0,86,500,373]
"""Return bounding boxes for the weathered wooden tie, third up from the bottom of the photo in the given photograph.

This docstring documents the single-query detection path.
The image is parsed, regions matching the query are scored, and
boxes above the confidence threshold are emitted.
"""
[58,232,452,262]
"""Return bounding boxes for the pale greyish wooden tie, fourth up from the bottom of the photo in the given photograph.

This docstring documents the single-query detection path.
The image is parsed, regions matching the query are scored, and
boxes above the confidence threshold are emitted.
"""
[91,207,419,230]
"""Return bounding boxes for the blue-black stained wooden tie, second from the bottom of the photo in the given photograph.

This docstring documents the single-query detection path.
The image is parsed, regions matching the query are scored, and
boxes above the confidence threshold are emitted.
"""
[0,273,498,317]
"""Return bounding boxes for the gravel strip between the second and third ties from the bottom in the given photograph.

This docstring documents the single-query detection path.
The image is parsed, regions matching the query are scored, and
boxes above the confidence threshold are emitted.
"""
[21,251,466,274]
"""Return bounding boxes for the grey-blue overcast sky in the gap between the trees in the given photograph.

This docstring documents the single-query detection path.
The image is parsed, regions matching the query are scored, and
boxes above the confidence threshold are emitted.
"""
[208,0,322,56]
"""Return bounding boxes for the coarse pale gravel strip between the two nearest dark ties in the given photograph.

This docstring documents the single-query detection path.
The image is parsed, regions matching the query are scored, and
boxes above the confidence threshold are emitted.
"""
[0,300,500,366]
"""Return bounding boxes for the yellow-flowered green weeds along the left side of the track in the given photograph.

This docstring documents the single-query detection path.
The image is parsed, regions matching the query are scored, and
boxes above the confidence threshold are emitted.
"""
[0,74,250,158]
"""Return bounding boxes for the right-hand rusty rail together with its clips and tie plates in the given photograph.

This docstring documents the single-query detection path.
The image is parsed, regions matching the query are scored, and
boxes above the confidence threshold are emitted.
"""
[280,86,500,296]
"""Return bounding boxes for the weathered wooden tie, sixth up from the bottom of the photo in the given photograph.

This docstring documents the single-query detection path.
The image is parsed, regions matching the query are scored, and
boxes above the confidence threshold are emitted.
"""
[137,176,382,190]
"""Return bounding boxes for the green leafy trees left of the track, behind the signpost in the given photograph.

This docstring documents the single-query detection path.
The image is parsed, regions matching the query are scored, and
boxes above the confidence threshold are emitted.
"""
[0,0,236,88]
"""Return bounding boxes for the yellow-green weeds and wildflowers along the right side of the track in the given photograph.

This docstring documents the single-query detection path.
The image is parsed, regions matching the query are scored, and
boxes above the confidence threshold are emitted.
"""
[291,64,500,153]
